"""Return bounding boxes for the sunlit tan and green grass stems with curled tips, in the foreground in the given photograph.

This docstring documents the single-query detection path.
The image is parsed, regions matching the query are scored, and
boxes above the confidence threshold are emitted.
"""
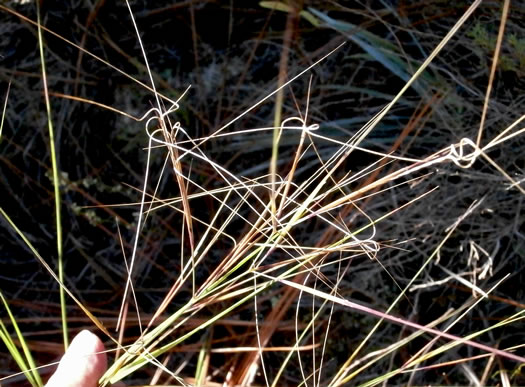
[0,0,525,386]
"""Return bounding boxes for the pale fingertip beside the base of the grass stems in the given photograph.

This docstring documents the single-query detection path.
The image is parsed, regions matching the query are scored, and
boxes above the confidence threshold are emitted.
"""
[46,330,107,387]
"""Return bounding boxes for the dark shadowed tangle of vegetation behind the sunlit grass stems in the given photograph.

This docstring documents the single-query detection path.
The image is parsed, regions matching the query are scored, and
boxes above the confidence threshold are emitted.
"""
[0,0,525,385]
